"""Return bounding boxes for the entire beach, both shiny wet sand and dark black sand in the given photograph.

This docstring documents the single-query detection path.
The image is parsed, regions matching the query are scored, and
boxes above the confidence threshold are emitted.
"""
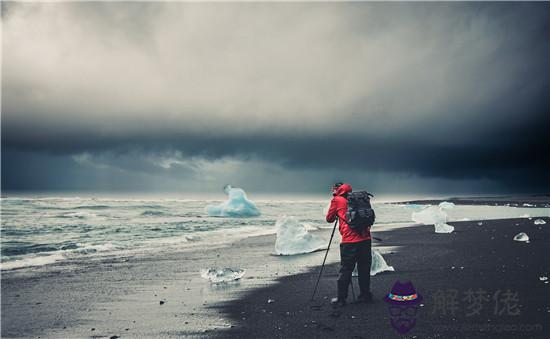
[2,218,550,338]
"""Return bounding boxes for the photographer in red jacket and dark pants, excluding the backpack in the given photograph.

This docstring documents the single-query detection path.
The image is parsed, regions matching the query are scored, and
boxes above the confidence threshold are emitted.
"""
[327,183,372,306]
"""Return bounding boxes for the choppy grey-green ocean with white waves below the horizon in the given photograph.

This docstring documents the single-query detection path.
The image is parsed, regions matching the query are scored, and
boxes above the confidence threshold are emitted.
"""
[0,196,550,270]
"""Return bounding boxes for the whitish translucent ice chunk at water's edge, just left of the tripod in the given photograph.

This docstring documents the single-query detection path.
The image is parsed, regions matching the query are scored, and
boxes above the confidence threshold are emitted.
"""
[275,216,328,255]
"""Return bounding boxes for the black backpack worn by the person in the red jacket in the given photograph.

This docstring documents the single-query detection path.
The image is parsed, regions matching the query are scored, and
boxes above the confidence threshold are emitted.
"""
[346,191,375,233]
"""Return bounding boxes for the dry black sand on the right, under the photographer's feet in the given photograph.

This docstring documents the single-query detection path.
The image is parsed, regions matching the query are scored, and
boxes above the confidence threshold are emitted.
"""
[211,218,550,338]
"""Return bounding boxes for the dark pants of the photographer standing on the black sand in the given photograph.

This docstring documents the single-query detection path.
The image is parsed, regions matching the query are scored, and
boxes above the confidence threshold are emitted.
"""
[338,240,372,300]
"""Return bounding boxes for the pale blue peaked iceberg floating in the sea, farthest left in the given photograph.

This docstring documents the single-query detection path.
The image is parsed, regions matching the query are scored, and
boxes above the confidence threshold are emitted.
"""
[206,185,260,217]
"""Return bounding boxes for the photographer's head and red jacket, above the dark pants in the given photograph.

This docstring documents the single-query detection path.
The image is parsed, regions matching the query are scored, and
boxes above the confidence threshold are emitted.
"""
[327,184,370,243]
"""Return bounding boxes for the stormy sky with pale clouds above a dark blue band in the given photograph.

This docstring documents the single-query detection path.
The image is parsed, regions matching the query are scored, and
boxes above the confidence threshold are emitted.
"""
[2,2,550,194]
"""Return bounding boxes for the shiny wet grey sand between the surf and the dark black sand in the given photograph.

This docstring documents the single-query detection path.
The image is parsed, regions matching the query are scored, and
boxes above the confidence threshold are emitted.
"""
[1,229,337,338]
